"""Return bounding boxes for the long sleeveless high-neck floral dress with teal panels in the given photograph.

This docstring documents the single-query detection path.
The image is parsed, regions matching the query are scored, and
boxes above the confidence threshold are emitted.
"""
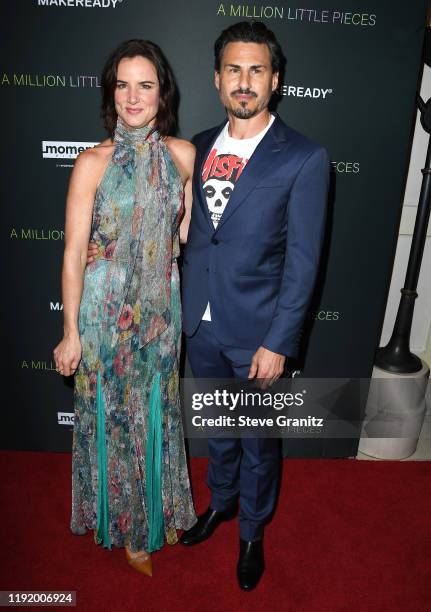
[71,120,196,552]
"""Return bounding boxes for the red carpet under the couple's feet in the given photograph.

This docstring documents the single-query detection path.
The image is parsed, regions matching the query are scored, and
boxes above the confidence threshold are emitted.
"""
[0,452,431,612]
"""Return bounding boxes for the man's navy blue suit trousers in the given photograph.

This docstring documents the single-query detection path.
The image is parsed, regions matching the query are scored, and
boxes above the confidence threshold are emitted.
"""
[186,321,280,541]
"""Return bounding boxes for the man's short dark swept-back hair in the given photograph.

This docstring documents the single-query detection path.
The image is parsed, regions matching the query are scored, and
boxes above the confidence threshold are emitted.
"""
[214,21,285,72]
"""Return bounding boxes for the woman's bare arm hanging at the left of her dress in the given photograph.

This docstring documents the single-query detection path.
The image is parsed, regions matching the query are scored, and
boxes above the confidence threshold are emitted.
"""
[54,149,101,376]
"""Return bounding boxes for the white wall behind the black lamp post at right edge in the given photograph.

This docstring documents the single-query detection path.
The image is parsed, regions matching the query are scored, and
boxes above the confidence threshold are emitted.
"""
[380,66,431,365]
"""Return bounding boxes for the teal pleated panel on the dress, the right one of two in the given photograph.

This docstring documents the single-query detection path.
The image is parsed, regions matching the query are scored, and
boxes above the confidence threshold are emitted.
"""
[146,374,164,552]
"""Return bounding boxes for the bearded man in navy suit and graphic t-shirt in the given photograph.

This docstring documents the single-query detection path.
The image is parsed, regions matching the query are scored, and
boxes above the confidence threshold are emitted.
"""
[181,22,329,590]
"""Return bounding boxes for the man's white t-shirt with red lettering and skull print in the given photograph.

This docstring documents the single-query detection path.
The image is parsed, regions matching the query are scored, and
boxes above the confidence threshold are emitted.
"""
[202,115,275,321]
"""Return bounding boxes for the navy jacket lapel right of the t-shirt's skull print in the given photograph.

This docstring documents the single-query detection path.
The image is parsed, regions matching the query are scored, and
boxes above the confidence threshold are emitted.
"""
[216,115,287,231]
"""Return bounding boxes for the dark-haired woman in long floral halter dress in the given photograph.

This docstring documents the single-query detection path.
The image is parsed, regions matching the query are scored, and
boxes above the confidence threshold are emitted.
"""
[54,40,196,575]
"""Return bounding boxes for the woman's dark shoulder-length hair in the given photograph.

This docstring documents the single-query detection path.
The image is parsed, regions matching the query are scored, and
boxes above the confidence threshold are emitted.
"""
[101,39,178,136]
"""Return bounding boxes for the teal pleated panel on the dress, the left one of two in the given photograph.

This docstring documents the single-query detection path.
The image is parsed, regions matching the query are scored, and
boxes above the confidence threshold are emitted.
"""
[96,372,111,550]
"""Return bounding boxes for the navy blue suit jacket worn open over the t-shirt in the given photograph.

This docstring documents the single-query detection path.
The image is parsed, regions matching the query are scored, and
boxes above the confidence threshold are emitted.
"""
[182,115,329,357]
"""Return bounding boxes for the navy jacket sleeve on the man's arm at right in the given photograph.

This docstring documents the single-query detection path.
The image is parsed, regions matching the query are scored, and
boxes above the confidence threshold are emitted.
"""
[262,148,329,357]
